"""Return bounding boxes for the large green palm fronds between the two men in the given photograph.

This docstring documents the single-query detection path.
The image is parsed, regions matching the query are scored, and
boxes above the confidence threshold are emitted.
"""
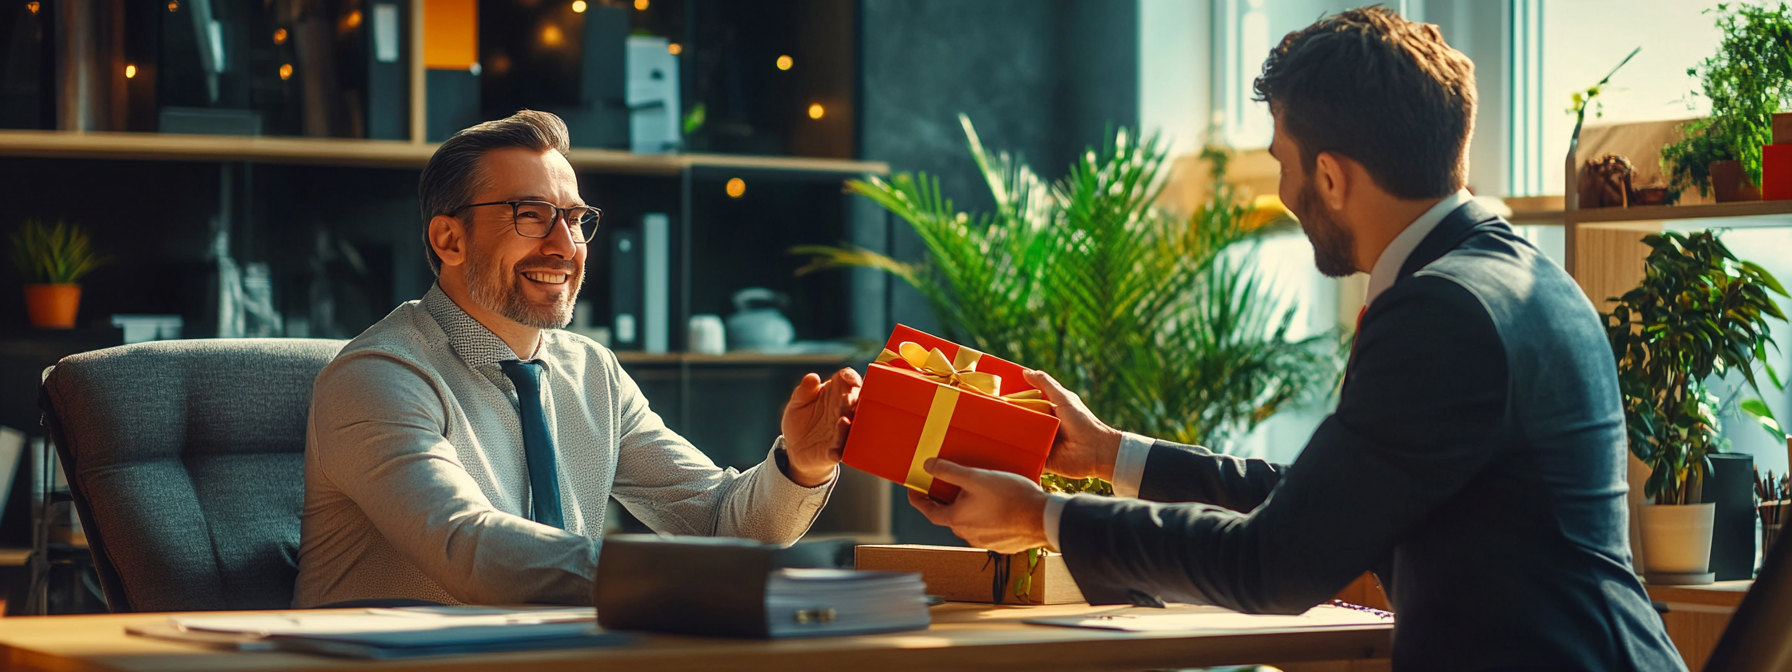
[792,116,1339,489]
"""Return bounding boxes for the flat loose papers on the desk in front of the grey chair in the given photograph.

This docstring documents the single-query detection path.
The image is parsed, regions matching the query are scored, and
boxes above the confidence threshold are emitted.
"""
[127,607,633,658]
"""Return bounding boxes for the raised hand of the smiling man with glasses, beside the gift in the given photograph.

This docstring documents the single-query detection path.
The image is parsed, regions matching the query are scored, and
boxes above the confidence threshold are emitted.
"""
[780,367,866,487]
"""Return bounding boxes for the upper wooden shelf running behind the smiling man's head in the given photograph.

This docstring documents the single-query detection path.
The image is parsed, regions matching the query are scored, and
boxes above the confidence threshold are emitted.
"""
[0,131,891,176]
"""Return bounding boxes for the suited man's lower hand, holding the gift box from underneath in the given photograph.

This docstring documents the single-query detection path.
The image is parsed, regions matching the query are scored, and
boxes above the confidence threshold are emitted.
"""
[909,457,1047,554]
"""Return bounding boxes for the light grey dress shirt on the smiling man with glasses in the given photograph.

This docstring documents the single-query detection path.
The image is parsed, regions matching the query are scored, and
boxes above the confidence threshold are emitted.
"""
[292,287,833,607]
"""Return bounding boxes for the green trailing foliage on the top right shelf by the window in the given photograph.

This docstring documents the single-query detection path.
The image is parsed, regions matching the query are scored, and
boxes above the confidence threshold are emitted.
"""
[1661,2,1792,194]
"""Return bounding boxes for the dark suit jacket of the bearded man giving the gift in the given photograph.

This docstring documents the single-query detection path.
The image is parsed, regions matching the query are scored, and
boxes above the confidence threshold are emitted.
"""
[1059,202,1684,670]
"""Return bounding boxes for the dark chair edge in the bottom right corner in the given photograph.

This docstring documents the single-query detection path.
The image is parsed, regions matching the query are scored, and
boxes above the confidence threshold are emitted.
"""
[1704,512,1792,672]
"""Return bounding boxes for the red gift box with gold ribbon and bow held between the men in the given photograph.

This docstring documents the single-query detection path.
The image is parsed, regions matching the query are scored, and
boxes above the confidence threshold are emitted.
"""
[842,324,1057,502]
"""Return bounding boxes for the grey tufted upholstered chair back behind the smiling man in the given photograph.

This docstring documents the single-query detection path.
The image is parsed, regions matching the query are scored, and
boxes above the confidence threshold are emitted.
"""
[39,339,344,611]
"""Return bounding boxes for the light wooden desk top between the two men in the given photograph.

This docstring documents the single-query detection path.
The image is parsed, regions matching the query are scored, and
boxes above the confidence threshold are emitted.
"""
[0,604,1392,672]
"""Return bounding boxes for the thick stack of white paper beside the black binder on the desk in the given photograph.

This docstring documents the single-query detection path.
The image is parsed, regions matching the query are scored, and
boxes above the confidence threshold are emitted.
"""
[765,570,930,638]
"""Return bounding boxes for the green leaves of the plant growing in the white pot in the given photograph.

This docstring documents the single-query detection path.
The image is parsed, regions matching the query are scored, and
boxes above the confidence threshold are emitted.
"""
[1602,231,1787,504]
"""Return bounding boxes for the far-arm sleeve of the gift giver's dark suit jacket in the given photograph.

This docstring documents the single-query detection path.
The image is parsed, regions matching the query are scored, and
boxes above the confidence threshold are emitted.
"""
[1138,441,1288,511]
